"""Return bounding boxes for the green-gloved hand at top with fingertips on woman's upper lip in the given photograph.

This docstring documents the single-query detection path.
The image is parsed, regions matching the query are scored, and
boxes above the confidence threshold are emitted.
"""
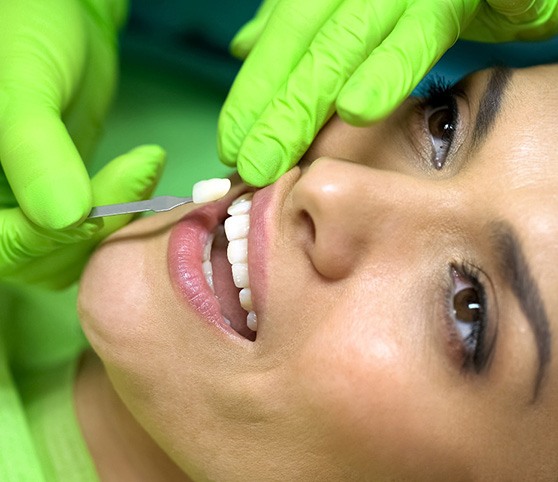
[218,0,558,186]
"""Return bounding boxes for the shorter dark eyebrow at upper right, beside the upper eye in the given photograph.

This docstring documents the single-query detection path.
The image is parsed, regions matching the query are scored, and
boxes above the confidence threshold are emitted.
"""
[473,66,513,149]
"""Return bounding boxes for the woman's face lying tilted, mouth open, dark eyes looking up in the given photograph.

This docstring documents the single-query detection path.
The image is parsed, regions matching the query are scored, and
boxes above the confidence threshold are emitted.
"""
[80,67,558,480]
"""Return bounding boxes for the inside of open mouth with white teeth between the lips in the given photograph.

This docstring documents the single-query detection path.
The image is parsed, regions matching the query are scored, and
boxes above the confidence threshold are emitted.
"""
[202,193,258,341]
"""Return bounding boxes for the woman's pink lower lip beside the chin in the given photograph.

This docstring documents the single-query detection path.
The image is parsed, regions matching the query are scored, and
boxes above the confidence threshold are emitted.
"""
[167,199,236,334]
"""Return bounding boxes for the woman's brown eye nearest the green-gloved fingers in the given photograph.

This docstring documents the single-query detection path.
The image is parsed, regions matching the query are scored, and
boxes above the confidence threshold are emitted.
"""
[424,99,457,170]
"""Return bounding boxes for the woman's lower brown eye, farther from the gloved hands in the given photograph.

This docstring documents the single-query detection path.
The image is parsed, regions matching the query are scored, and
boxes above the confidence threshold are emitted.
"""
[449,267,488,372]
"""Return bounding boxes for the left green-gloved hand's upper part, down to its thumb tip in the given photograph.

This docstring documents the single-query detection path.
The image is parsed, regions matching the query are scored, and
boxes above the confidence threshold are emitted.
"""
[0,0,127,230]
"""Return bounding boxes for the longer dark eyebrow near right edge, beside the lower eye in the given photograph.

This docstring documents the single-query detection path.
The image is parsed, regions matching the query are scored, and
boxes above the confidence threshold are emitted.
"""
[490,221,551,402]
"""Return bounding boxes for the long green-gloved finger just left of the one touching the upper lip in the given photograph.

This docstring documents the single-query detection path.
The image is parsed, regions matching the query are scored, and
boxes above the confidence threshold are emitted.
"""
[218,0,343,166]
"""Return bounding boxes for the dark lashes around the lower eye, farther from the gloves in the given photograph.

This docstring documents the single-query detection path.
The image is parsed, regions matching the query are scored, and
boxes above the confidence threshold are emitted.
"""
[445,262,493,373]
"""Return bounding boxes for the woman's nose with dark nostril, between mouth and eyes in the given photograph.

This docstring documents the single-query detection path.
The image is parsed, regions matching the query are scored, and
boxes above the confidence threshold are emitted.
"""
[292,158,455,280]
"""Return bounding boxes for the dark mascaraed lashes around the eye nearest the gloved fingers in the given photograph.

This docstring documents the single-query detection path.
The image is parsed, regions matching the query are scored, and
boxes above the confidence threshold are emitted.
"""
[417,77,462,171]
